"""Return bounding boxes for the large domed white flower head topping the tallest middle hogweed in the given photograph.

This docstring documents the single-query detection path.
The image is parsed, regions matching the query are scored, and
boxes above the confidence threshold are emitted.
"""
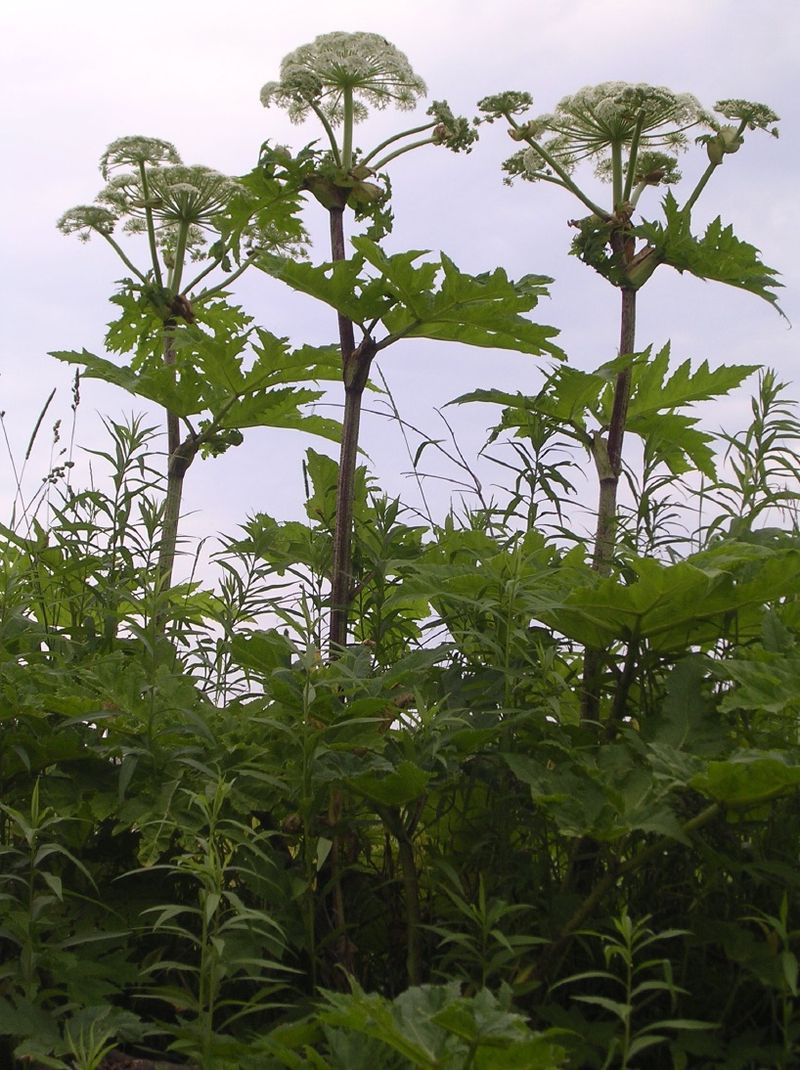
[261,32,426,126]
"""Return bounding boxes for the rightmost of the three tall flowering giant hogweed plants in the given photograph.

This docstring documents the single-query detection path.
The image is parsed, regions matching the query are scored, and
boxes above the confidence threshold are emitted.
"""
[473,81,780,719]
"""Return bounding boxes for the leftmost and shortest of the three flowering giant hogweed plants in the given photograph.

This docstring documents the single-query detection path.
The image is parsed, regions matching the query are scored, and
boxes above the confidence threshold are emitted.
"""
[53,137,338,590]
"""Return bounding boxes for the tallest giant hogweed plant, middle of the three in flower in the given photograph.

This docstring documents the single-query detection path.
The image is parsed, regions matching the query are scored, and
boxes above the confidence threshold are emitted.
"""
[261,32,555,654]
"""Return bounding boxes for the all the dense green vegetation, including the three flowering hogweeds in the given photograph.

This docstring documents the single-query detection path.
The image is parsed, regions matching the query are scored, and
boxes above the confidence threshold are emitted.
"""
[0,34,800,1070]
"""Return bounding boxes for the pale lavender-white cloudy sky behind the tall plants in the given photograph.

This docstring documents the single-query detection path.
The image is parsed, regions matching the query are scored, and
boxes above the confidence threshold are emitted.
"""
[0,0,800,564]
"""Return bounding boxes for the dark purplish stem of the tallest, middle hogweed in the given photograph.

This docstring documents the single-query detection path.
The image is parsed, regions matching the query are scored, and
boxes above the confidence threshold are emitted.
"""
[328,205,375,657]
